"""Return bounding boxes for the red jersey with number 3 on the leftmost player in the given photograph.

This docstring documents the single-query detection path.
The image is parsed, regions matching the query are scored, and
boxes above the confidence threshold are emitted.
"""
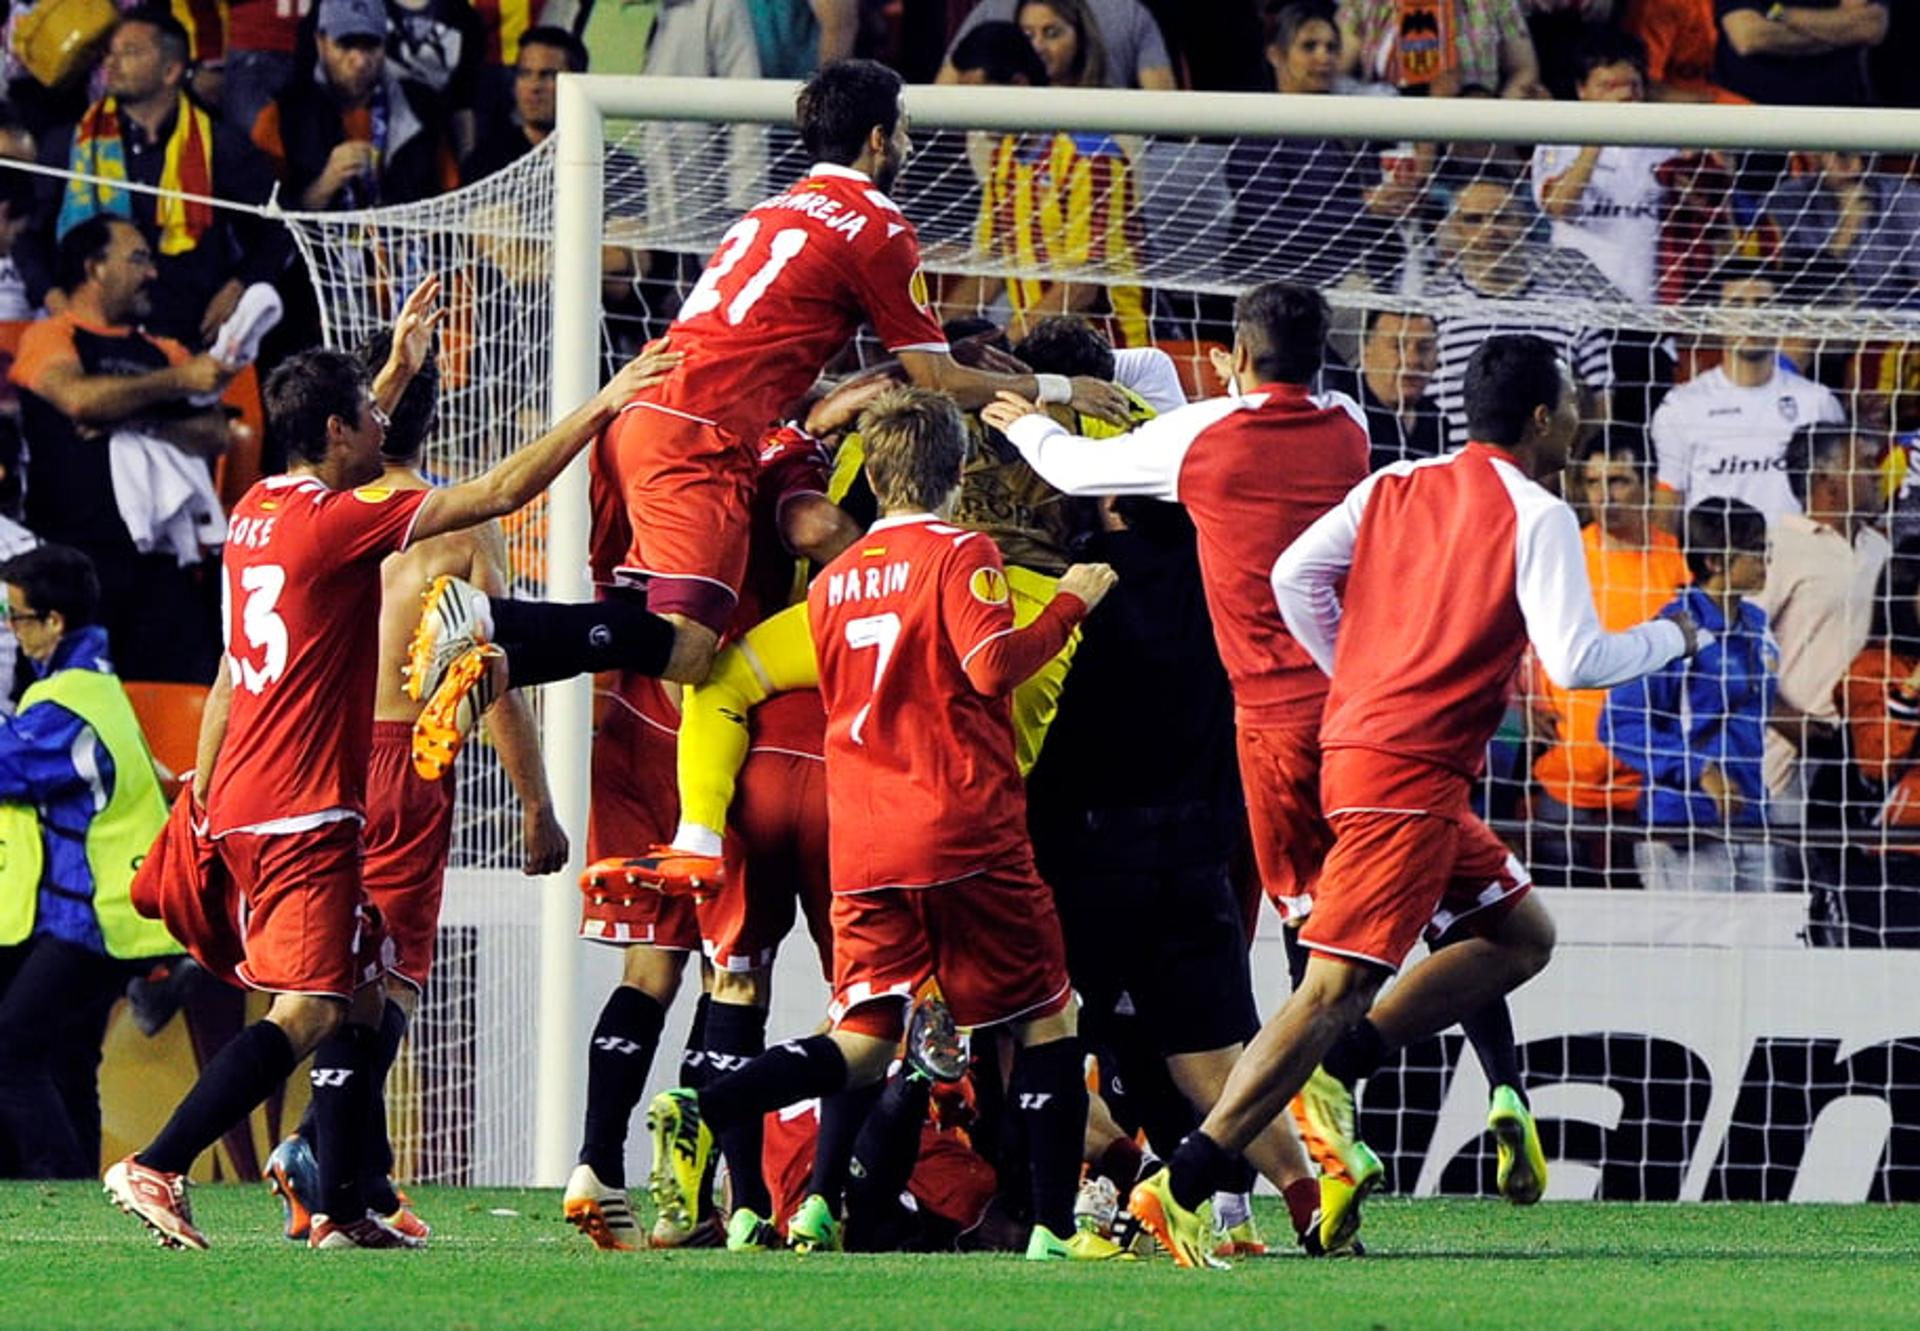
[207,476,430,835]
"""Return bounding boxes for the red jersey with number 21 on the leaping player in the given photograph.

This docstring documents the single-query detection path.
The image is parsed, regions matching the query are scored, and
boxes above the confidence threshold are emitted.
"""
[639,165,947,446]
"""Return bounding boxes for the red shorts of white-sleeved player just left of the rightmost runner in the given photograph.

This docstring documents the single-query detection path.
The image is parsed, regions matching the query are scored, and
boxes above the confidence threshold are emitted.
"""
[1238,722,1332,937]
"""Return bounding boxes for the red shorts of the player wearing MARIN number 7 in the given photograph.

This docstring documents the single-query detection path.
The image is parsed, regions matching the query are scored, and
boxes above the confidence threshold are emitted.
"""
[831,860,1073,1026]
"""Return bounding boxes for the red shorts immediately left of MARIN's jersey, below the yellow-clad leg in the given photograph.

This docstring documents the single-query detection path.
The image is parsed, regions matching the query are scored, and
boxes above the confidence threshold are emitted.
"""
[699,749,833,980]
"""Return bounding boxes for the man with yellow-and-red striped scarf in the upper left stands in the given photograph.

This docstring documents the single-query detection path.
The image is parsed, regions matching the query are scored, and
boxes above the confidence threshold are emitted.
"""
[46,8,290,346]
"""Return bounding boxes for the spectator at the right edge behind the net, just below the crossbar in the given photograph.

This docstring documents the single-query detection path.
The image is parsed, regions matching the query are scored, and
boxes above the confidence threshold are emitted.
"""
[1763,152,1920,307]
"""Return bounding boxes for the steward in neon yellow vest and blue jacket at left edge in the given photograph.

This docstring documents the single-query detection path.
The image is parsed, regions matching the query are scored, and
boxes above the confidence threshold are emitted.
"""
[0,545,180,1179]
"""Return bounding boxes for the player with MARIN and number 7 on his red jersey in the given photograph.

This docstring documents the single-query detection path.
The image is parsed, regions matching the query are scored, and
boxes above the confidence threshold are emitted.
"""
[647,388,1117,1258]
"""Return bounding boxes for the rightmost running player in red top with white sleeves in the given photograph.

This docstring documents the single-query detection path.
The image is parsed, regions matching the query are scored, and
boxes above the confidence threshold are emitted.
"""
[1135,334,1697,1266]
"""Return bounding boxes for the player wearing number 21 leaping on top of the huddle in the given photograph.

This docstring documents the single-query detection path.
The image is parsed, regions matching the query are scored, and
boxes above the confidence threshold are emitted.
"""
[397,60,1127,779]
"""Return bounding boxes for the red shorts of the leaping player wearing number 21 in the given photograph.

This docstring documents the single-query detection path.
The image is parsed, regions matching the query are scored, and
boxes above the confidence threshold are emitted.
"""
[593,401,755,634]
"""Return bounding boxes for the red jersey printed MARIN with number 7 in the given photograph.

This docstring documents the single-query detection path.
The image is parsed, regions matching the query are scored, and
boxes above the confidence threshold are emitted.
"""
[806,515,1033,891]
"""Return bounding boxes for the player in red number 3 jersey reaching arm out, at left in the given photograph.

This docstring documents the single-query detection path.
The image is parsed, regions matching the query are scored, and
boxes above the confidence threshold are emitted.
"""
[106,278,676,1248]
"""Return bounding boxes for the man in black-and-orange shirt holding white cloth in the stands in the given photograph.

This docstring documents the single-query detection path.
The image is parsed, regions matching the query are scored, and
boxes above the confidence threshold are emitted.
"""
[12,215,232,684]
